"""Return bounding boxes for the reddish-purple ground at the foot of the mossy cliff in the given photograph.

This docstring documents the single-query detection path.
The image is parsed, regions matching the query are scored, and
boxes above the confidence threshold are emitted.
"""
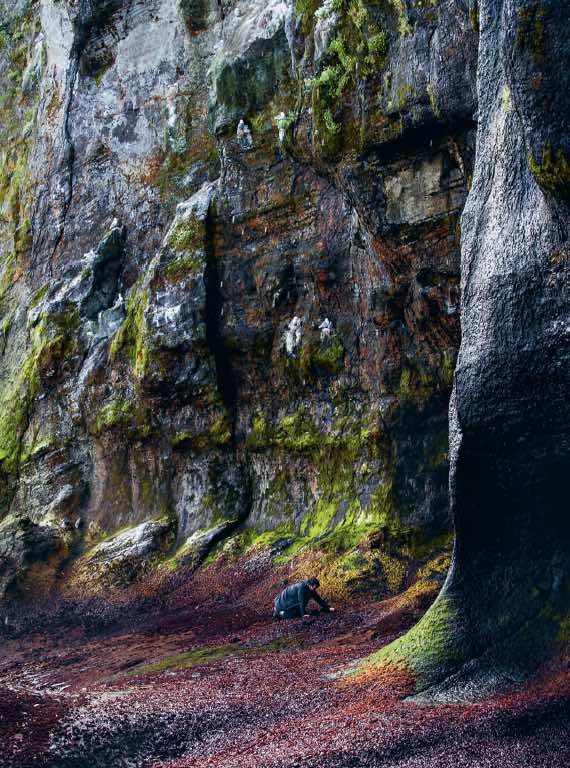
[0,558,570,768]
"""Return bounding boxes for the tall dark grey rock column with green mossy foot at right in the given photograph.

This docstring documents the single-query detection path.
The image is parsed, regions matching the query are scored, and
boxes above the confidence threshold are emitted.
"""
[372,0,570,700]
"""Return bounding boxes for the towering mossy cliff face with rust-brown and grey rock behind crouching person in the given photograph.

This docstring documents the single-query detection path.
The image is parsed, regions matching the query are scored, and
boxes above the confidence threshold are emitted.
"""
[0,0,480,589]
